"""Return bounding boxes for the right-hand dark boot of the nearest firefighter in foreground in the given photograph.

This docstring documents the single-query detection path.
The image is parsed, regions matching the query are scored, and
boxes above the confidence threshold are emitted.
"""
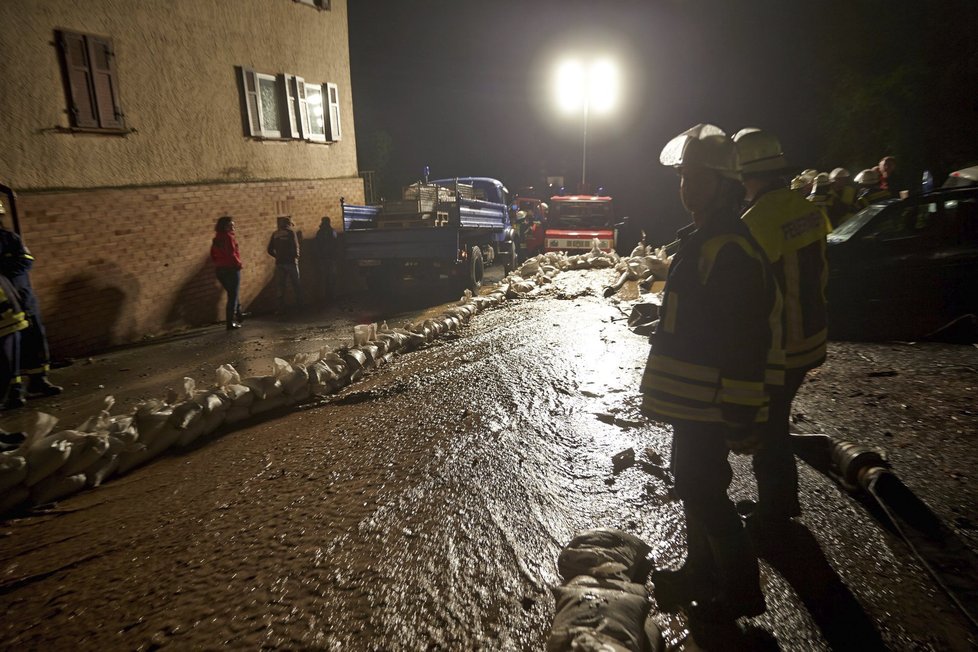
[690,527,767,620]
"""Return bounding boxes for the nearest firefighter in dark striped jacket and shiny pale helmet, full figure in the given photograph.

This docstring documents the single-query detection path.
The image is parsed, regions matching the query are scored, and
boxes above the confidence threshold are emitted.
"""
[641,125,780,619]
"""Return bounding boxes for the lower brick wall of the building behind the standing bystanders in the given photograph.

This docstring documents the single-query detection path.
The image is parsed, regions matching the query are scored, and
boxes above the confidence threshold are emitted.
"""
[18,177,363,358]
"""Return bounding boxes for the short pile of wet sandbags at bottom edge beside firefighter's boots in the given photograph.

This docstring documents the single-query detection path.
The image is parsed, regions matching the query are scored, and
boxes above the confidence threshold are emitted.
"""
[547,528,665,652]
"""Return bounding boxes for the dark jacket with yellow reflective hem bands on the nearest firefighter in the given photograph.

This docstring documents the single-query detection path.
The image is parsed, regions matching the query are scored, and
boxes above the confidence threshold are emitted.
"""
[641,215,780,426]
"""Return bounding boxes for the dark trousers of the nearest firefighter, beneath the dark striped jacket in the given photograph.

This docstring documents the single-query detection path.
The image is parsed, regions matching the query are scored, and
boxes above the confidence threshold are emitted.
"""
[672,422,742,538]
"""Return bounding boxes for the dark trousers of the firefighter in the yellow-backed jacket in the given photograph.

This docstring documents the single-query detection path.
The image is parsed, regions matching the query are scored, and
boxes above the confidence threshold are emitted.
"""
[751,369,807,517]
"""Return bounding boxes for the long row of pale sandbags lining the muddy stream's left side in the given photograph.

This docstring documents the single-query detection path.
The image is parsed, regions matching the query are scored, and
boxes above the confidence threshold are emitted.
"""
[0,287,506,514]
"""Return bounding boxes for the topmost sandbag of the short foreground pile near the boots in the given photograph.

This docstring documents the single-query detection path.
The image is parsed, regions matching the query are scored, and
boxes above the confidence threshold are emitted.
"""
[557,528,652,582]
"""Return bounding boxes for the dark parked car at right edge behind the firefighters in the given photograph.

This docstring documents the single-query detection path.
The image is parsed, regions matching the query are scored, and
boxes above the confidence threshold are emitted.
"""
[828,187,978,339]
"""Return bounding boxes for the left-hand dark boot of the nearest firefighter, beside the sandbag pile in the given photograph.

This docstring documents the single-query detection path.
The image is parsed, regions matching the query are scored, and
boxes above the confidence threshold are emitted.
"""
[651,512,717,613]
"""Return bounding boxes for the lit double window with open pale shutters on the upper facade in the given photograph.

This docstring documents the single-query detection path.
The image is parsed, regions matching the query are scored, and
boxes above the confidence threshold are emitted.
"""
[239,68,342,143]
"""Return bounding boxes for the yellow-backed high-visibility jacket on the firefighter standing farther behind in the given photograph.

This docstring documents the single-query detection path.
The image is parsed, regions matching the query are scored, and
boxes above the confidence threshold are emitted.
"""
[743,188,832,369]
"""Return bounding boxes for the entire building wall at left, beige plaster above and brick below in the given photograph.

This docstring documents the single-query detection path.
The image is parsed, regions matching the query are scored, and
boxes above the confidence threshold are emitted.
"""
[0,0,363,357]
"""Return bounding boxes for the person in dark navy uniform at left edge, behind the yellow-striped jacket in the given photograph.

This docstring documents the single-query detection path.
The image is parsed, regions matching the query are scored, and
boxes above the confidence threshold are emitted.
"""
[0,204,62,409]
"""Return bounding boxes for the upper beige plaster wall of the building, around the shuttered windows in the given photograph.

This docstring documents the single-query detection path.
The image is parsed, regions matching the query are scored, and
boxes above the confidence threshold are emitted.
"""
[0,0,357,191]
